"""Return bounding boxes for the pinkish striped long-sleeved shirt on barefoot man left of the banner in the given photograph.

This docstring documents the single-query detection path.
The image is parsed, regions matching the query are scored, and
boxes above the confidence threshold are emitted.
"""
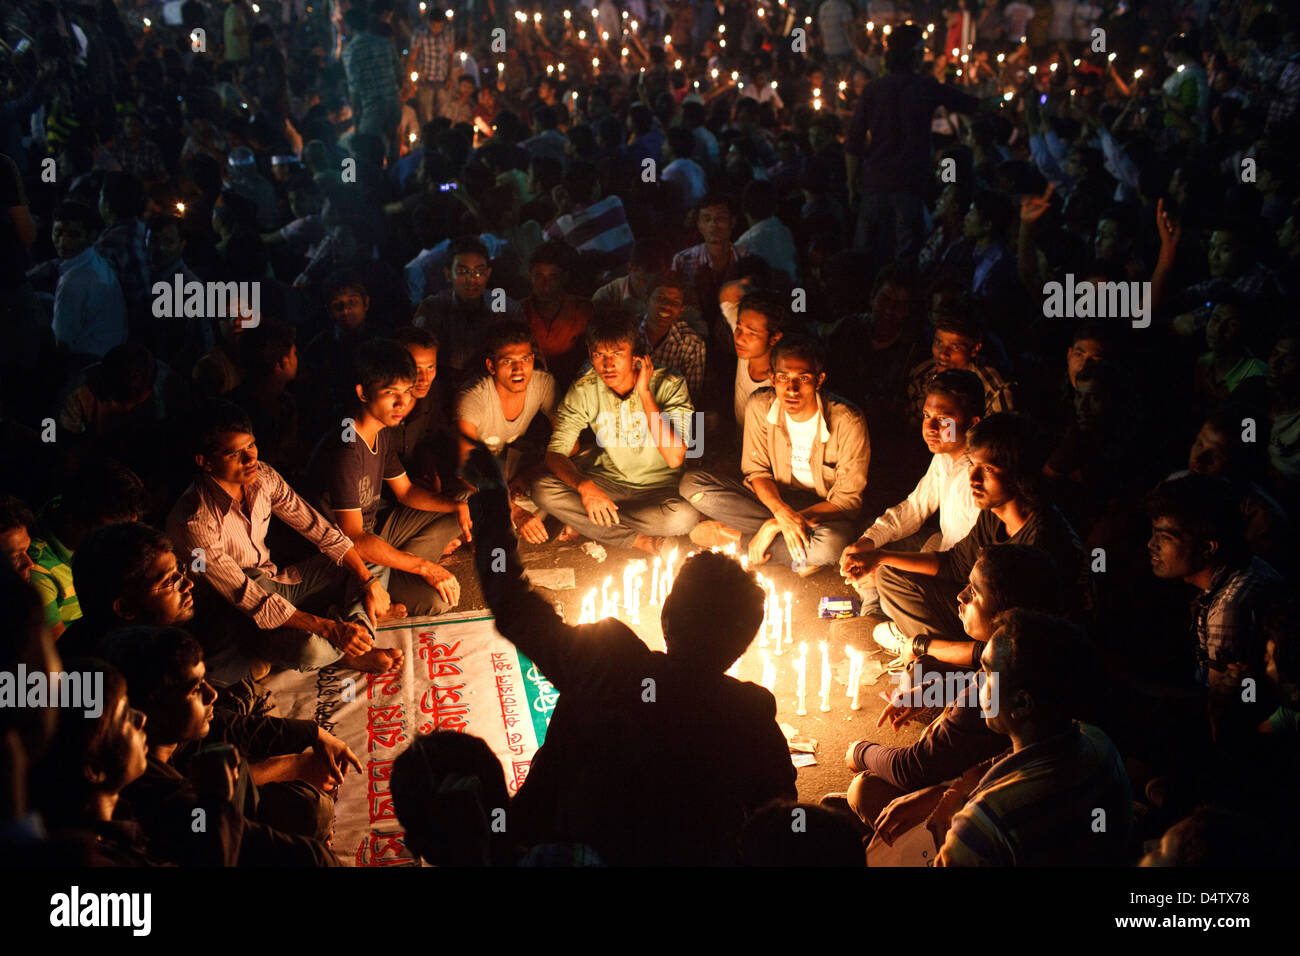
[168,462,352,631]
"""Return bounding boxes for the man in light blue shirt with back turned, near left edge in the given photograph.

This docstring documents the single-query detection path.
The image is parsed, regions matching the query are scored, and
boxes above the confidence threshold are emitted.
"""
[52,202,126,364]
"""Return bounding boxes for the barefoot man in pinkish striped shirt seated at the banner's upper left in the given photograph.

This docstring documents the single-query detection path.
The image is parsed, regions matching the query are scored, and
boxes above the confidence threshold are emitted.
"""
[168,402,402,684]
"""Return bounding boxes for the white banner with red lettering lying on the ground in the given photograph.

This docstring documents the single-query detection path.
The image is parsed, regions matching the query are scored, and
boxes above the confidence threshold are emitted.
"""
[265,610,558,866]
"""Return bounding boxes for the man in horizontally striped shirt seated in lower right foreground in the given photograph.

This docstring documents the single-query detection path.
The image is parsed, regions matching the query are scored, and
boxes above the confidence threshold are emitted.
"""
[931,610,1134,866]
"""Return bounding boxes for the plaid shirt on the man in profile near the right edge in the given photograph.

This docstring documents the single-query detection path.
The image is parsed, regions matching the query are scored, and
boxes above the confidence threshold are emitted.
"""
[1192,558,1283,684]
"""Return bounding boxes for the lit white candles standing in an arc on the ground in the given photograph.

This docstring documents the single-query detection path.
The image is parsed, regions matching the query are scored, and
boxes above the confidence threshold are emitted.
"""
[579,545,866,717]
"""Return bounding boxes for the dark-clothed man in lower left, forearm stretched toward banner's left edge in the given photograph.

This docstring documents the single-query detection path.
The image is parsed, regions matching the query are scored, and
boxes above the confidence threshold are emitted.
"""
[104,627,348,866]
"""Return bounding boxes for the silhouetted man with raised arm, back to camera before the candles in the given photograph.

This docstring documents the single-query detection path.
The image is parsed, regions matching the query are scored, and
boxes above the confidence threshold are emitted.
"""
[467,447,796,865]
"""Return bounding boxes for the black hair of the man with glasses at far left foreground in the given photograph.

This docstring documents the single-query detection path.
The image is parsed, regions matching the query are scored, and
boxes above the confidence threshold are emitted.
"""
[73,522,172,620]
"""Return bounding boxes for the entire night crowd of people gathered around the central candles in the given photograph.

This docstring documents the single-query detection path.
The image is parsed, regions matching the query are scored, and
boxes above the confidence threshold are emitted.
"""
[0,0,1300,866]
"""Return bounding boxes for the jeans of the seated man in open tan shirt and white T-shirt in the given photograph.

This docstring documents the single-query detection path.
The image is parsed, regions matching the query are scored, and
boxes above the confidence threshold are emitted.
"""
[680,471,854,567]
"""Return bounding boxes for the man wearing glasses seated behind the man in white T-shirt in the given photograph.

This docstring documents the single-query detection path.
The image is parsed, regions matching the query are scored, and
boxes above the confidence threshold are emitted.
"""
[412,235,524,394]
